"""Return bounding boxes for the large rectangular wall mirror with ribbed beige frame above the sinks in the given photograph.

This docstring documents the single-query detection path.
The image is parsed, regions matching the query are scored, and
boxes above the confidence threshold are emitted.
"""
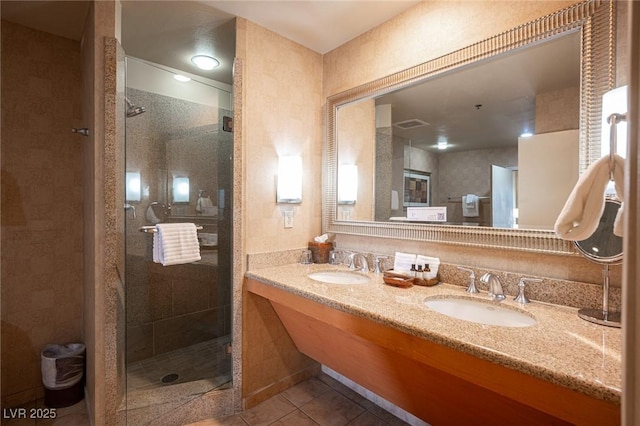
[323,1,615,255]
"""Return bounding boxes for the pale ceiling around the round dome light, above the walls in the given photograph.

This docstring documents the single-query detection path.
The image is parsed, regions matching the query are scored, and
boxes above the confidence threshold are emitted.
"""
[2,0,420,84]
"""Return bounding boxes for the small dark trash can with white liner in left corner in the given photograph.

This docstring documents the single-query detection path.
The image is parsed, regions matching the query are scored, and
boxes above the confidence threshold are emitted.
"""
[41,343,85,408]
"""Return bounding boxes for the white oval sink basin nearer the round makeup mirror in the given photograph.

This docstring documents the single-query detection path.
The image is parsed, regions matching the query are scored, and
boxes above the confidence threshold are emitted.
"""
[424,297,537,327]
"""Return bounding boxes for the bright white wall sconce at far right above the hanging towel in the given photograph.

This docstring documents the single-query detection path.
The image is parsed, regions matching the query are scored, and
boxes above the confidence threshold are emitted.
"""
[600,86,628,158]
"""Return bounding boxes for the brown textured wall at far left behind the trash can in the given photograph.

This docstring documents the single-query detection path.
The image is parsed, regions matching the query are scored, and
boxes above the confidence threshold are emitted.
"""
[2,21,85,407]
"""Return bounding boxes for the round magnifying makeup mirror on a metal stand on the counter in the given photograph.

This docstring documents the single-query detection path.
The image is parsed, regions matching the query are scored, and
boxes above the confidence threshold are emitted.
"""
[574,198,622,327]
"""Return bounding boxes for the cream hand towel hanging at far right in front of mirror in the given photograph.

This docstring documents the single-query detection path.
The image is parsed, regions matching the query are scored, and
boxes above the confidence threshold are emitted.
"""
[554,155,624,241]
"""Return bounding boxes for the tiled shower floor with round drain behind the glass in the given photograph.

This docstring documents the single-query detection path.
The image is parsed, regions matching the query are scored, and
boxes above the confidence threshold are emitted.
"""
[127,336,231,392]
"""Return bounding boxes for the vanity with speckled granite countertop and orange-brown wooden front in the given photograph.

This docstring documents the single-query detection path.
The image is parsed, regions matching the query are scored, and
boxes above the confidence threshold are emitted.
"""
[246,264,622,425]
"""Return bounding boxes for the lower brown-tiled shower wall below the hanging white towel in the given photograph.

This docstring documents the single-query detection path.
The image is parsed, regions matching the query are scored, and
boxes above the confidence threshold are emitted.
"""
[126,253,231,363]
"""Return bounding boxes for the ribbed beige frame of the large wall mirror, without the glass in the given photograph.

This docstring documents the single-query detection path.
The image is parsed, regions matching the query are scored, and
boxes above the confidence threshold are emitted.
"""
[322,0,615,256]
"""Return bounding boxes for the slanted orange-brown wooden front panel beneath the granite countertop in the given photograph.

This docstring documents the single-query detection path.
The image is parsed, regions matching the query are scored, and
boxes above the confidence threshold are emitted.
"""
[247,279,620,426]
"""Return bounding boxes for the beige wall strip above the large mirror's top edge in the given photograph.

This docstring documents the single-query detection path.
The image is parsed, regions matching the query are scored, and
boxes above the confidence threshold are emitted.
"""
[323,0,578,96]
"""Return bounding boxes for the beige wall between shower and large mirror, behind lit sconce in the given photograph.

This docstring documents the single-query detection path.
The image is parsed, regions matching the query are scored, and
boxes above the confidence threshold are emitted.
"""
[237,19,322,253]
